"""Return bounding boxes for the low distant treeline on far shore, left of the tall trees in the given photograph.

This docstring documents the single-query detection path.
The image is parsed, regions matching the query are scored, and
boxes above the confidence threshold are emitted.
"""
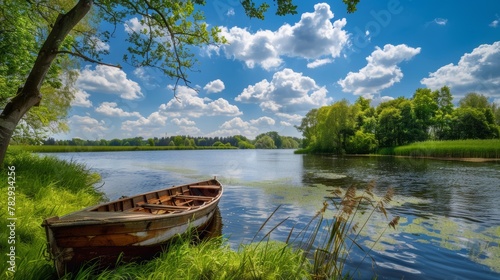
[43,131,302,149]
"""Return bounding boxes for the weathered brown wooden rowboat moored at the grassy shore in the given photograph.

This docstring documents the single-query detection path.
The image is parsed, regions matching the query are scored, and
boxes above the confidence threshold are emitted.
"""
[42,178,222,276]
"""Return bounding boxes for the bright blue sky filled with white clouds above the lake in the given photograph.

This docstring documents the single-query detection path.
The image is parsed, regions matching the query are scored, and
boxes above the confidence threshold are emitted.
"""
[56,0,500,140]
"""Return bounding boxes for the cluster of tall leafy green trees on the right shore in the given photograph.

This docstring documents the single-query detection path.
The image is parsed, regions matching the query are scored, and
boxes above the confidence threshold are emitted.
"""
[297,87,500,154]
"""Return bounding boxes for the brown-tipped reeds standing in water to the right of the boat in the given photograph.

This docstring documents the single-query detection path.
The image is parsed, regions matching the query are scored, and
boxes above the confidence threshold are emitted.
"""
[258,182,399,280]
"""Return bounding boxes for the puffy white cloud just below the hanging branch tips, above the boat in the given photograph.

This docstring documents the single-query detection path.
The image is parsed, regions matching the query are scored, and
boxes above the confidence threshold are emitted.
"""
[160,86,243,118]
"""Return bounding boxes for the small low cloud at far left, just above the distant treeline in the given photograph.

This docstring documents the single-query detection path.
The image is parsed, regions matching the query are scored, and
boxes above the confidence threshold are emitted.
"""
[68,115,108,139]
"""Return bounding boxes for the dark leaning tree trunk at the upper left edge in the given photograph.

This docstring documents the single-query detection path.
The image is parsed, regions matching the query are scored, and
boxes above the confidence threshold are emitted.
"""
[0,0,93,164]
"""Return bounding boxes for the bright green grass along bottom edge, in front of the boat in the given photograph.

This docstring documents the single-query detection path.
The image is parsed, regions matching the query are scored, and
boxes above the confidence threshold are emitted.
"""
[65,238,309,280]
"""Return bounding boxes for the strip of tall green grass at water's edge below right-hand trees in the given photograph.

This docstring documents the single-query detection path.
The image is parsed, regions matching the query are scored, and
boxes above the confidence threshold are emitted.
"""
[379,139,500,159]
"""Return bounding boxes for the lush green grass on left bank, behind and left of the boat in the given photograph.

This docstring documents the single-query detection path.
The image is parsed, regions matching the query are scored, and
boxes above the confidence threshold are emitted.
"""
[0,152,103,279]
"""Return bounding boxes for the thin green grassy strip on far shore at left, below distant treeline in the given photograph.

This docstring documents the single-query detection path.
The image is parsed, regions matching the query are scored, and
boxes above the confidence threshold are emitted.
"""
[12,145,237,153]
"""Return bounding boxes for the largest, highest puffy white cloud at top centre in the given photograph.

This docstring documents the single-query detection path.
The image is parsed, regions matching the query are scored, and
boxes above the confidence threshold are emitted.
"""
[217,3,349,70]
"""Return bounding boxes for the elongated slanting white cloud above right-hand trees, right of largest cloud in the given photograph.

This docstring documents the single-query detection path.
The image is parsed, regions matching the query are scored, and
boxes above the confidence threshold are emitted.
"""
[337,44,420,98]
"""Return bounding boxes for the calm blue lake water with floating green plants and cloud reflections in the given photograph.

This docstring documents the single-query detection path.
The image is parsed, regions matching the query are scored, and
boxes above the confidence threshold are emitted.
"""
[45,150,500,279]
